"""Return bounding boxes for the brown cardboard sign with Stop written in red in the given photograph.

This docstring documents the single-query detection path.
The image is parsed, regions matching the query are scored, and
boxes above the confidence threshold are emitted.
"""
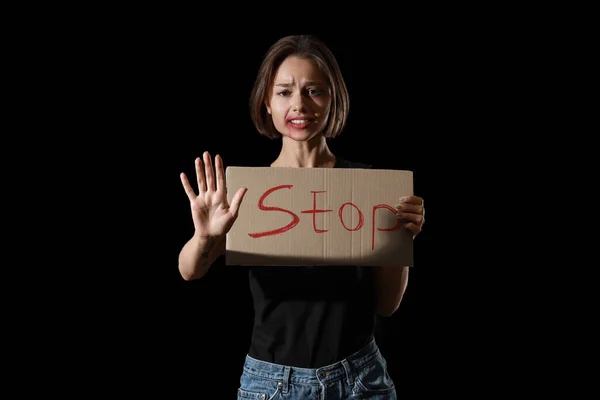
[226,167,413,266]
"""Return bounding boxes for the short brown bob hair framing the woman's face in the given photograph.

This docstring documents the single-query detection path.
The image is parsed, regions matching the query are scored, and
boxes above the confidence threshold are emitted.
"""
[250,35,350,139]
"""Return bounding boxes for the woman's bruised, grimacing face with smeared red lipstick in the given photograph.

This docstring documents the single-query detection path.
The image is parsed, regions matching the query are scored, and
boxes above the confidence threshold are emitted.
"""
[266,56,331,141]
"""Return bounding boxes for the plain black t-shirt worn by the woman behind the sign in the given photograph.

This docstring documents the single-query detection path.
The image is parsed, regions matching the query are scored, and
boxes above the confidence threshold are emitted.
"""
[249,158,376,368]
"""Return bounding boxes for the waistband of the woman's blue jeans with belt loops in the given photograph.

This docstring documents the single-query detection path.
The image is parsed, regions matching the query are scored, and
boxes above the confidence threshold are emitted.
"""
[244,339,380,393]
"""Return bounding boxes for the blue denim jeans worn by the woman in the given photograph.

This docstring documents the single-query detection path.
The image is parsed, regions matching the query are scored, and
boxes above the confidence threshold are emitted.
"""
[237,340,397,400]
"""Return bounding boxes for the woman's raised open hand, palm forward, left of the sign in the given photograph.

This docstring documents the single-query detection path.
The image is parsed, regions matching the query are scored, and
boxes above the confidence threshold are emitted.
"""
[180,152,247,239]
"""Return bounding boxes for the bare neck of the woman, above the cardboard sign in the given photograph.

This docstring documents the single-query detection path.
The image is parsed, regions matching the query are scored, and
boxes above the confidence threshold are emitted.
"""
[271,135,336,168]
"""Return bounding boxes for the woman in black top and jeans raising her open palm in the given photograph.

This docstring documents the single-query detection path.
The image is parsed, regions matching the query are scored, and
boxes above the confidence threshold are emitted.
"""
[179,35,424,400]
